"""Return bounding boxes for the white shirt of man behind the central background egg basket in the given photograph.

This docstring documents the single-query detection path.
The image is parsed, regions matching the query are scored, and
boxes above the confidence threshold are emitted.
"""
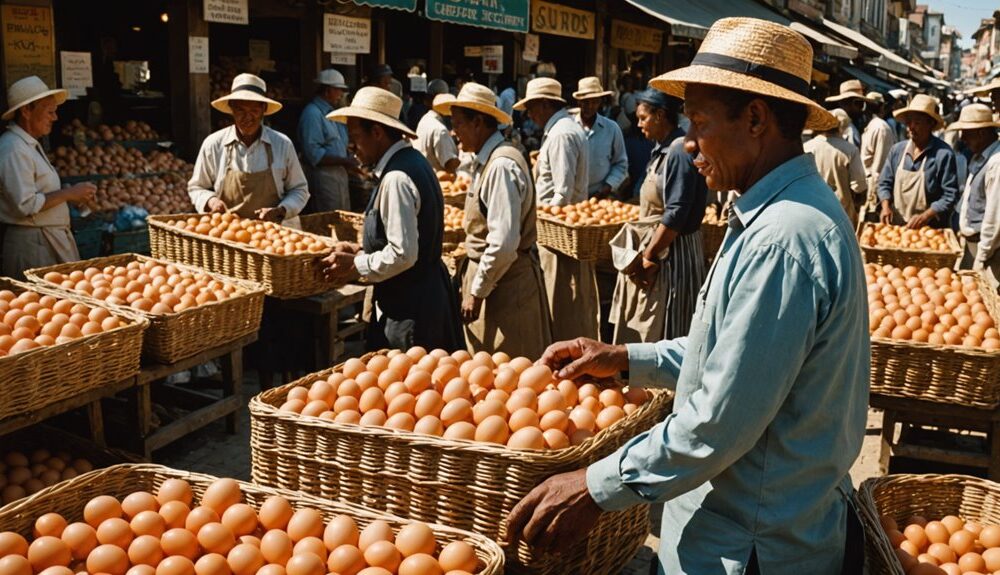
[535,108,589,206]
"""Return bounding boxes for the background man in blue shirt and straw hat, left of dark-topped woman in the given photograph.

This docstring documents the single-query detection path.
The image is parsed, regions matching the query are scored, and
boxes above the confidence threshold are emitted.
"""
[573,76,628,198]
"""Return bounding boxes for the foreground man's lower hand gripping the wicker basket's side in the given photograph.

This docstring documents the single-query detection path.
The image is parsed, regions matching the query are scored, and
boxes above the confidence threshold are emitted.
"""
[507,469,602,553]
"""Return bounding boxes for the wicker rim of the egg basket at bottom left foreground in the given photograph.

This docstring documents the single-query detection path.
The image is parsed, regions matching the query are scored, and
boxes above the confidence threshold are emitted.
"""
[0,464,504,575]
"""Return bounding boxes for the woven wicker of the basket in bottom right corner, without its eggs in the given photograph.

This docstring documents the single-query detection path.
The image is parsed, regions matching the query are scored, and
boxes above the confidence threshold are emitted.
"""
[856,475,1000,575]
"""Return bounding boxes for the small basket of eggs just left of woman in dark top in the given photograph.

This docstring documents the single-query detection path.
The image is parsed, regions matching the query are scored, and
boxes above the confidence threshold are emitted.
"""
[538,198,639,261]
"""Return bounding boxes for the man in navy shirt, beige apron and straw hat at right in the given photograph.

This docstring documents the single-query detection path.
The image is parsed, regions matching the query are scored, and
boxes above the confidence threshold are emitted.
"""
[878,94,959,228]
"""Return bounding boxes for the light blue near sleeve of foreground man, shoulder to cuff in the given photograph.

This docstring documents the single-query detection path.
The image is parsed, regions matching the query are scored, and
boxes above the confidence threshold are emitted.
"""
[587,245,825,511]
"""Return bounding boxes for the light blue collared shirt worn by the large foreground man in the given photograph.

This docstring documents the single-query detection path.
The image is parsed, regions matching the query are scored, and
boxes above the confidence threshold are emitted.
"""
[587,155,870,575]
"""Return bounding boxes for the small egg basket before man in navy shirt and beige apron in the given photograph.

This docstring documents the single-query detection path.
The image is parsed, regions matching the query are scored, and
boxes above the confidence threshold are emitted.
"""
[859,222,962,269]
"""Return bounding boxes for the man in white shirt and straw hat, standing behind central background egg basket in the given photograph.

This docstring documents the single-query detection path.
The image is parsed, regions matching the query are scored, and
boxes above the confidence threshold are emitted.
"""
[514,78,600,340]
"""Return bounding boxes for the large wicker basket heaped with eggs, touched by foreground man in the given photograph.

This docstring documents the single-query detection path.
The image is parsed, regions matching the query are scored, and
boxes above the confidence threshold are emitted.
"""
[250,347,672,575]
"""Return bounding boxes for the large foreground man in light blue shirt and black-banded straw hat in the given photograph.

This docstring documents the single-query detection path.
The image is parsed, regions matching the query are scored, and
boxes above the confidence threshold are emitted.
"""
[507,18,870,575]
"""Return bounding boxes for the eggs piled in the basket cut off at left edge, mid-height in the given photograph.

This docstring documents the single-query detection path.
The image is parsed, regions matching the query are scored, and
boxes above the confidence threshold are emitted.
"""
[0,290,122,357]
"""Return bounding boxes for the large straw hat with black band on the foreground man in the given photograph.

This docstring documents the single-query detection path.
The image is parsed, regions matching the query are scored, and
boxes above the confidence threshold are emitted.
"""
[649,18,837,131]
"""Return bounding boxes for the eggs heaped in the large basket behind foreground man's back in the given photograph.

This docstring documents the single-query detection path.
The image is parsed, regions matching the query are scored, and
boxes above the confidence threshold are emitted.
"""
[865,264,1000,351]
